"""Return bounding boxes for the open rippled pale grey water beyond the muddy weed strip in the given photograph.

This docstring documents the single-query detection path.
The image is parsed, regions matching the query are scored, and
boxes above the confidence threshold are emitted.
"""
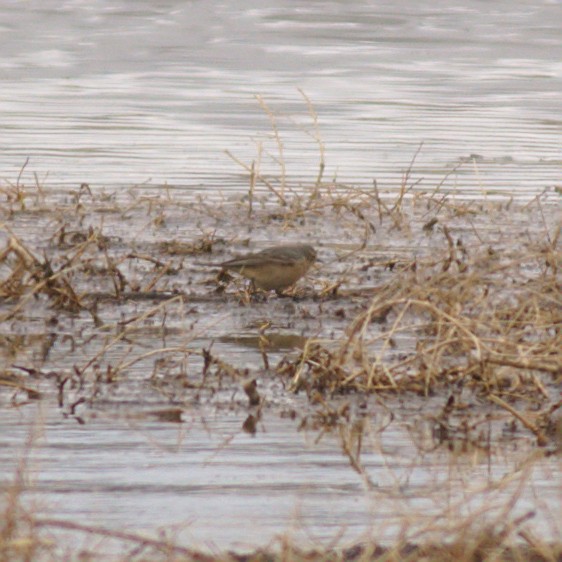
[0,0,562,197]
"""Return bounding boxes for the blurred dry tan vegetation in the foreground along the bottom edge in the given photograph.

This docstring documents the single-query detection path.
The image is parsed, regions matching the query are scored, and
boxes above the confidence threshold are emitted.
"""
[0,450,562,562]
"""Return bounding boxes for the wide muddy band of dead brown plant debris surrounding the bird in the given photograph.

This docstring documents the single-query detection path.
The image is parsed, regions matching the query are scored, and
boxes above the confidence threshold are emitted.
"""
[0,164,562,444]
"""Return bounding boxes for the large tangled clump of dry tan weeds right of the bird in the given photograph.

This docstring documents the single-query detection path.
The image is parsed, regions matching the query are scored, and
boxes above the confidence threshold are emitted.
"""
[277,215,562,444]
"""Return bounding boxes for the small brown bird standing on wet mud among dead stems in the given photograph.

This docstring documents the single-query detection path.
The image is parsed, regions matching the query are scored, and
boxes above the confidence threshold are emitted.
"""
[219,244,316,294]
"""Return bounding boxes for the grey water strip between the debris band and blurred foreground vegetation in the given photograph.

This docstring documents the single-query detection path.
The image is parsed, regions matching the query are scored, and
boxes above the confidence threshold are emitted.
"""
[0,400,560,548]
